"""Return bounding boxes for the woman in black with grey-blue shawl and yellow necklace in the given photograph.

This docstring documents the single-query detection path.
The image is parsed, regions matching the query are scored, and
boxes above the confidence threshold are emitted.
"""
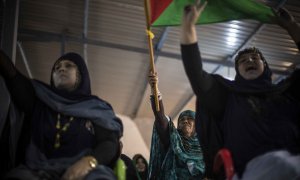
[0,51,123,179]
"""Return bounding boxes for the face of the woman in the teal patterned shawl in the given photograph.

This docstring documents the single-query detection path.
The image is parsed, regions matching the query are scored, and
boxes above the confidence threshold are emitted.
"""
[178,116,195,137]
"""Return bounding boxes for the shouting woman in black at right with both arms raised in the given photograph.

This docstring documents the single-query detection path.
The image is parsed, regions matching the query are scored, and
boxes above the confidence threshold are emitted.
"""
[181,0,300,179]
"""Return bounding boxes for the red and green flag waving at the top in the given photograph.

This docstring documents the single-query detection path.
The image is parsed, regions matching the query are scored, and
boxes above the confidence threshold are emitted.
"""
[149,0,274,26]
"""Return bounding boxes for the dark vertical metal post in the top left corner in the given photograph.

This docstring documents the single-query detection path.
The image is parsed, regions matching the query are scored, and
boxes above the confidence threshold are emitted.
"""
[1,0,19,64]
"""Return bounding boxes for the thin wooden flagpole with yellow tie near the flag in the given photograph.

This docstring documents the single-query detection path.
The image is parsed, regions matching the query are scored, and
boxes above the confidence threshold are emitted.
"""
[144,0,160,111]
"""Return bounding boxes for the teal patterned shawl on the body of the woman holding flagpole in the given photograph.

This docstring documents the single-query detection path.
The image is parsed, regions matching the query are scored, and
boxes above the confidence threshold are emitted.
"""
[149,121,205,180]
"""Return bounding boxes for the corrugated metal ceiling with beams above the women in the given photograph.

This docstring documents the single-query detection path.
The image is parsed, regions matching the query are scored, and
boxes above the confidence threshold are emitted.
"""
[1,0,300,146]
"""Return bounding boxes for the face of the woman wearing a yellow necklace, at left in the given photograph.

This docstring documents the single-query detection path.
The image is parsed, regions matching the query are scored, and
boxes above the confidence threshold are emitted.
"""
[52,60,78,91]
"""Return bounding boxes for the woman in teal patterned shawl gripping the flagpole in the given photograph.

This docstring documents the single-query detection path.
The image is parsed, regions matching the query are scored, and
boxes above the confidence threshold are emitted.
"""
[149,73,204,180]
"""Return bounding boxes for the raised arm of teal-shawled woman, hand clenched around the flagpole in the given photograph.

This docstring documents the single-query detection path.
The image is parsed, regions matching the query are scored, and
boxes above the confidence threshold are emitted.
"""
[149,72,170,149]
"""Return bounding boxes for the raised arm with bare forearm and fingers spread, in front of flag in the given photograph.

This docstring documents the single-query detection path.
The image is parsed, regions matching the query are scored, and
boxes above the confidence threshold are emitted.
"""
[180,1,227,115]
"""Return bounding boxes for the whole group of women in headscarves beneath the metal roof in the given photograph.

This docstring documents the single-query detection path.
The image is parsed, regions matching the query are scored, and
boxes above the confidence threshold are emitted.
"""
[0,2,300,180]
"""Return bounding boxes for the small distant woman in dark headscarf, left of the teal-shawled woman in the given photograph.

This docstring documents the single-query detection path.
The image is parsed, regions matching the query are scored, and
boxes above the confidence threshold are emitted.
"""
[132,154,148,180]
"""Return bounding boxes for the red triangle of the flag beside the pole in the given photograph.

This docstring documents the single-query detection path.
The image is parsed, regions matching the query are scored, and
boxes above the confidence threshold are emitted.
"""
[150,0,173,24]
